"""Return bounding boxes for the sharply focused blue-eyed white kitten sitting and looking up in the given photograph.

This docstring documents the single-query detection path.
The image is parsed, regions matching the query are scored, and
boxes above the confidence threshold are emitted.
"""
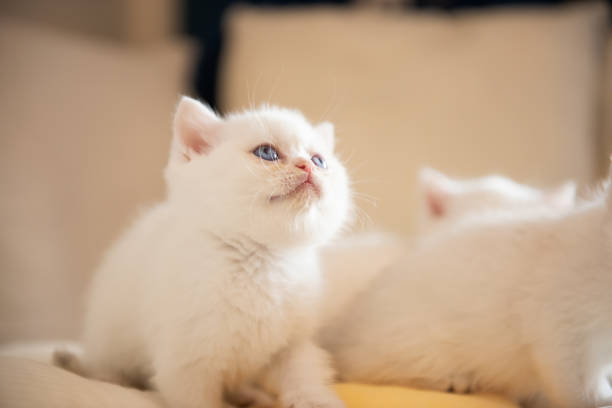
[76,97,351,408]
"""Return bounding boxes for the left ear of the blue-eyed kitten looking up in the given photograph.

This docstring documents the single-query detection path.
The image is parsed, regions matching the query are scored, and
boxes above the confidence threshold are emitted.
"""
[170,96,222,163]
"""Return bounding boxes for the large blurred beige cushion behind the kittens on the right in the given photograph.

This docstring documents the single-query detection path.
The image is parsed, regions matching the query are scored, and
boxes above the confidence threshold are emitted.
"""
[221,4,606,232]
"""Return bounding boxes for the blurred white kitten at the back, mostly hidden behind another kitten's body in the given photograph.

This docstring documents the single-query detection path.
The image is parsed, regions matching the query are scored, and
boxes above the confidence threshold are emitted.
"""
[321,168,576,324]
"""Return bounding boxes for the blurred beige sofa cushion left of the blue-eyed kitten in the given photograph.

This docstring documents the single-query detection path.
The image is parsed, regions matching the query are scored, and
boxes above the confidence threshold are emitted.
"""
[0,17,190,343]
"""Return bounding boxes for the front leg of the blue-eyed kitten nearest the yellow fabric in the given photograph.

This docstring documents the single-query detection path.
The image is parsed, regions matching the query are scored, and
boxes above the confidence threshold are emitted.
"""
[265,340,345,408]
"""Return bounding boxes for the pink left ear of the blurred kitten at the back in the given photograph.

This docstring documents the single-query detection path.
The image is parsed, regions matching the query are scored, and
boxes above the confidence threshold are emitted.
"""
[419,167,456,218]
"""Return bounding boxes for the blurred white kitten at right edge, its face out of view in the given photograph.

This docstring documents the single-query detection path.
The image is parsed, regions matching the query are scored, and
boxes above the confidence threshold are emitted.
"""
[325,167,612,408]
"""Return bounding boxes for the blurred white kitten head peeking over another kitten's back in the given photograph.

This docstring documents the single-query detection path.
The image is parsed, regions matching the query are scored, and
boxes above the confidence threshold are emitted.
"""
[419,168,576,224]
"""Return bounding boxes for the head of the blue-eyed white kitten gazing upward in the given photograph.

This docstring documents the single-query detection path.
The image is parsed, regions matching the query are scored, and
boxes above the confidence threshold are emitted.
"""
[166,97,351,246]
